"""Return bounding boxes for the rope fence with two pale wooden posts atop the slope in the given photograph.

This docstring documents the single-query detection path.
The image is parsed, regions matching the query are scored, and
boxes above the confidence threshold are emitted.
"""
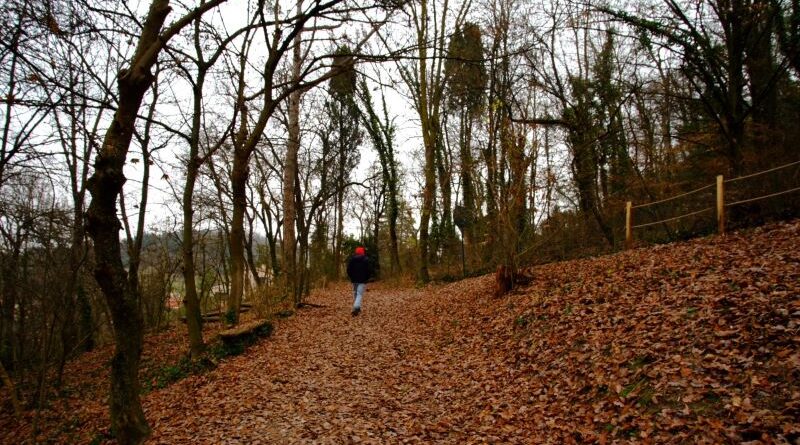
[625,161,800,246]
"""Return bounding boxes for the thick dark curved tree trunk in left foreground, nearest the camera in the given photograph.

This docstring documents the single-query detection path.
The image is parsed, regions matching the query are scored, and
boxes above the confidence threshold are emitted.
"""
[86,0,224,438]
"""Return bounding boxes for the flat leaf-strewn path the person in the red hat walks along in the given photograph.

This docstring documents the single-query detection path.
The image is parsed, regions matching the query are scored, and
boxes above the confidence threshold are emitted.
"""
[145,277,516,444]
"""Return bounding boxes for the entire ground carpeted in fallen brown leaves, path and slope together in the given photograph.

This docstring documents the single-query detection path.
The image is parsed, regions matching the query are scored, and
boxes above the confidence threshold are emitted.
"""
[0,222,800,444]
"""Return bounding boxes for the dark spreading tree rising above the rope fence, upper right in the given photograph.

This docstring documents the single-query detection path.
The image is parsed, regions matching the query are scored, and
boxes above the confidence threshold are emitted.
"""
[598,0,797,174]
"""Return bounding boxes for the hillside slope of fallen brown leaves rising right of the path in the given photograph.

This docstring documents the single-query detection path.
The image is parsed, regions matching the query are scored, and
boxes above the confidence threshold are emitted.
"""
[432,222,800,443]
